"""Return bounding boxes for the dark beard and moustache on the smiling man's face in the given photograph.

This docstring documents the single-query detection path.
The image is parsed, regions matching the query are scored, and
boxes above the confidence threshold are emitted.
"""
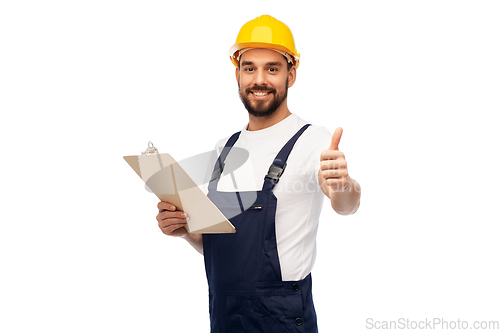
[238,78,288,117]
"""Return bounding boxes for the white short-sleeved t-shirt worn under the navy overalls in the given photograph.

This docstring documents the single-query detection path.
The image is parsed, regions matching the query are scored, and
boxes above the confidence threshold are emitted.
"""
[211,114,332,281]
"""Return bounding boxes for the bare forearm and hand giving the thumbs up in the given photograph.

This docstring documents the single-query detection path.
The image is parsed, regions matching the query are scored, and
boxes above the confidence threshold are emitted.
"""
[318,127,361,215]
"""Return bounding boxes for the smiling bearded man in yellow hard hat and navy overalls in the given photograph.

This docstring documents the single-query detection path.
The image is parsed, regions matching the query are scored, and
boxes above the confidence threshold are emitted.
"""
[157,15,360,333]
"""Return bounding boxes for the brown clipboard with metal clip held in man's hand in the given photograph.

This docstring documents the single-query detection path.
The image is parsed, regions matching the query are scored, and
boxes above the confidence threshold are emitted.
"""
[123,141,236,234]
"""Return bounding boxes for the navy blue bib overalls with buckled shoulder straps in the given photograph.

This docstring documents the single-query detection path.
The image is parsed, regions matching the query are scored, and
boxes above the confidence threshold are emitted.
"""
[203,125,318,333]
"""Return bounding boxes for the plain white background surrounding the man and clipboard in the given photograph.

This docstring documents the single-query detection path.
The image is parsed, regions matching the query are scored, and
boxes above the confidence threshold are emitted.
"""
[0,0,500,333]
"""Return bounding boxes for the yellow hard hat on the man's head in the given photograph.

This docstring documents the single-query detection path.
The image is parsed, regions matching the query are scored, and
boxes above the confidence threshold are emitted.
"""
[229,15,300,68]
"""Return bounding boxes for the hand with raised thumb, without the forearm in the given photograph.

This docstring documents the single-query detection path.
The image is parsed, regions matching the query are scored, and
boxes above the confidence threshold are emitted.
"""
[319,127,350,192]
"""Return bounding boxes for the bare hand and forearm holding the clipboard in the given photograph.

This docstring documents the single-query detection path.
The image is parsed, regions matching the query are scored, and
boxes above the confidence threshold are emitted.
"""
[156,201,203,254]
